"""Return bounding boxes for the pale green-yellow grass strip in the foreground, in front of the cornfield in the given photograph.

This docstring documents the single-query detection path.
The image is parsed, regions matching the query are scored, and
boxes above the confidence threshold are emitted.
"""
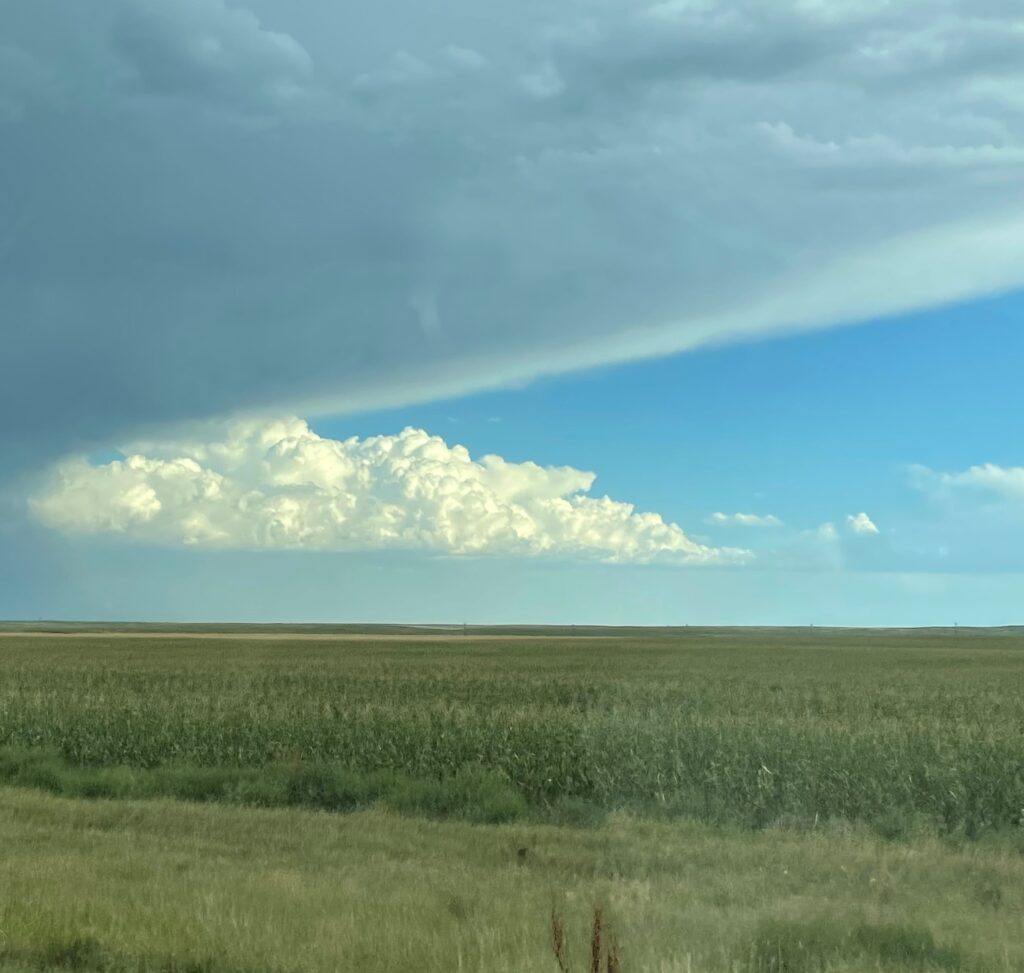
[0,788,1024,973]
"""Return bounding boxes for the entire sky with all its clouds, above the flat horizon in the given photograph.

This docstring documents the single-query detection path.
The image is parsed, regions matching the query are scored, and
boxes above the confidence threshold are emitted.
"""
[0,0,1024,625]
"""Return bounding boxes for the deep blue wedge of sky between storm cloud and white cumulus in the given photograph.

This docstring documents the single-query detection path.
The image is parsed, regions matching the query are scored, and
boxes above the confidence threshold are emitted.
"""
[321,294,1024,540]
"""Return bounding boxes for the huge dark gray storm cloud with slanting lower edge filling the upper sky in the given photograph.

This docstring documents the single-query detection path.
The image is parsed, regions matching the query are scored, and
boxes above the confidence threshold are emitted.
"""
[0,0,1024,468]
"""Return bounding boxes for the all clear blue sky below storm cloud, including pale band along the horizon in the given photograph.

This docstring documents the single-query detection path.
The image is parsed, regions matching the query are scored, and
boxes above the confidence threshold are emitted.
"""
[5,294,1024,625]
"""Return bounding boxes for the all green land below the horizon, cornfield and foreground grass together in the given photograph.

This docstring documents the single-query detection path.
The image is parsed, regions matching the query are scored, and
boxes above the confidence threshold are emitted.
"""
[0,627,1024,973]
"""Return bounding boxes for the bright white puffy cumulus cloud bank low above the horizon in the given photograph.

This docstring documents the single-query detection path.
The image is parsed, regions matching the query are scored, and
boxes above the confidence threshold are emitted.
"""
[31,419,751,564]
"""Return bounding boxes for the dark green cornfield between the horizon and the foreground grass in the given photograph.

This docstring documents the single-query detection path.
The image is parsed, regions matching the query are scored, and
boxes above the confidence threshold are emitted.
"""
[0,629,1024,839]
